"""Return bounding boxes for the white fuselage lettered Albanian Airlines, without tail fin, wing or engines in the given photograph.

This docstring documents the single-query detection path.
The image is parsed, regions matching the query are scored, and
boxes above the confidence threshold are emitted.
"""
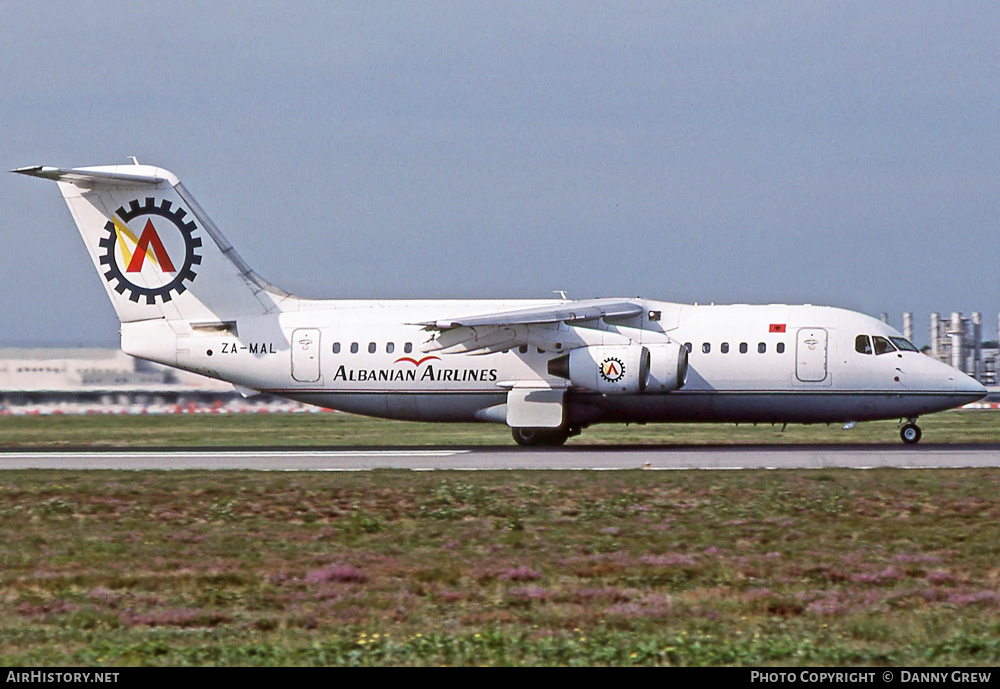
[122,300,985,425]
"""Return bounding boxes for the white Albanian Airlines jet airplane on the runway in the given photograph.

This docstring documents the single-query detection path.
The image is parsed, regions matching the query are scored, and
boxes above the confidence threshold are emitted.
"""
[13,158,986,446]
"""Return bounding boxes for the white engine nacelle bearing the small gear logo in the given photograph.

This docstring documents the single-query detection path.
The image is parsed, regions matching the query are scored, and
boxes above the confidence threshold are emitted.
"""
[548,344,650,395]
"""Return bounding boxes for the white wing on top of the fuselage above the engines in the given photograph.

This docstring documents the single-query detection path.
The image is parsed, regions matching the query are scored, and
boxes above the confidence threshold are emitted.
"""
[416,299,645,354]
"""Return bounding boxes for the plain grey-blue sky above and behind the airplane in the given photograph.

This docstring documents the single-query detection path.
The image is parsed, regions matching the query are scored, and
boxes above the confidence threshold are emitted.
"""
[0,0,1000,346]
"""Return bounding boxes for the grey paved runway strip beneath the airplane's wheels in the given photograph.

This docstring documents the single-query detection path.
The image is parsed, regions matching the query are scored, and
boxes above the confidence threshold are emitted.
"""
[0,444,1000,471]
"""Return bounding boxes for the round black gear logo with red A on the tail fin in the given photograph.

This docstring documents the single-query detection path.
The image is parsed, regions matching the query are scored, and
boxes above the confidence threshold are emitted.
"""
[100,197,201,304]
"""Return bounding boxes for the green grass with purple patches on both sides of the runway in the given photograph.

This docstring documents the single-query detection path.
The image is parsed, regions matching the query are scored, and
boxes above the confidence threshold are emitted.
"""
[0,412,1000,667]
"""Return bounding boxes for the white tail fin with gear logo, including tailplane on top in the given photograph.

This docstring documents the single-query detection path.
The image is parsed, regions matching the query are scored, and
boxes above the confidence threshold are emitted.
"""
[14,164,290,323]
